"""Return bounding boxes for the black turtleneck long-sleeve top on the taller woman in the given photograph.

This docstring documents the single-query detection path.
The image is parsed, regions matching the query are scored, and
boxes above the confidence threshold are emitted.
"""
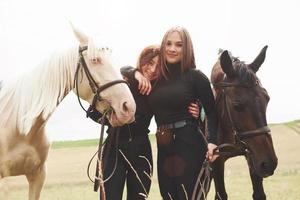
[148,64,218,144]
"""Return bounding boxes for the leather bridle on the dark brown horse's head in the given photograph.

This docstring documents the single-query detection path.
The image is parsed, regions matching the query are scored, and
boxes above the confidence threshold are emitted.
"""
[213,80,271,156]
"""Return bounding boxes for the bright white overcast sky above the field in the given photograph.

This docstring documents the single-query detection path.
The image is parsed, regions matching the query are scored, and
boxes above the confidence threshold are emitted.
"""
[0,0,300,140]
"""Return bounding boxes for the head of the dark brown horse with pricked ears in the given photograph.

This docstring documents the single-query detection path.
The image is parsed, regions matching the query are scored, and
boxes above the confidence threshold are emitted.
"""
[211,46,277,177]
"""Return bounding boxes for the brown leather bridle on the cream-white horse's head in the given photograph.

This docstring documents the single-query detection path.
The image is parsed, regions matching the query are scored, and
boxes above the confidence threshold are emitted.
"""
[74,46,128,117]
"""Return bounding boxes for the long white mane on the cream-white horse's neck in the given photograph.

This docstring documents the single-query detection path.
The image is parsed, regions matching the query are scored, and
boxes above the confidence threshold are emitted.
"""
[0,48,78,134]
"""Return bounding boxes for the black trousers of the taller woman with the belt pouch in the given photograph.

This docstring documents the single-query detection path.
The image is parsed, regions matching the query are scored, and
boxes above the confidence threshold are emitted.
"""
[157,125,207,200]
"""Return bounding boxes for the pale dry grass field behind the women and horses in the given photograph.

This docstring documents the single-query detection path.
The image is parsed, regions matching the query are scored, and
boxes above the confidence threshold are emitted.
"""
[0,121,300,200]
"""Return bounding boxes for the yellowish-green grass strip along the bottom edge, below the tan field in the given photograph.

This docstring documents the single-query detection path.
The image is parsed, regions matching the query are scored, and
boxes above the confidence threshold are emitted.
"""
[6,171,300,200]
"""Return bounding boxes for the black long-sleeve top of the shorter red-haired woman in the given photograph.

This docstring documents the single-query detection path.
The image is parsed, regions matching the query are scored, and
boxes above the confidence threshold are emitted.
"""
[89,66,153,138]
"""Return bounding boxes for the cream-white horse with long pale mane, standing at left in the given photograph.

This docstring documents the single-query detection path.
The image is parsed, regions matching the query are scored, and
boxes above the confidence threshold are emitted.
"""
[0,28,135,200]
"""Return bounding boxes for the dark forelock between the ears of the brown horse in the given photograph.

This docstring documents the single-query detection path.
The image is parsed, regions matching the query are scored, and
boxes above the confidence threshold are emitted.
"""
[233,59,257,87]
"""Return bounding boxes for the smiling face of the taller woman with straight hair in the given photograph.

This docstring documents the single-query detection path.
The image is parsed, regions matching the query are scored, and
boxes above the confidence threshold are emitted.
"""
[164,31,183,64]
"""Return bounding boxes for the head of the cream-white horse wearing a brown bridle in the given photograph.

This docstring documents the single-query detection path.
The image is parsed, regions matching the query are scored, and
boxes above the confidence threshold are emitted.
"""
[73,27,136,126]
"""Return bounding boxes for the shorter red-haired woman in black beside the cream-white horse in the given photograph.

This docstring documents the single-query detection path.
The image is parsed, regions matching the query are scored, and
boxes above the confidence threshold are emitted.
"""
[90,45,199,200]
